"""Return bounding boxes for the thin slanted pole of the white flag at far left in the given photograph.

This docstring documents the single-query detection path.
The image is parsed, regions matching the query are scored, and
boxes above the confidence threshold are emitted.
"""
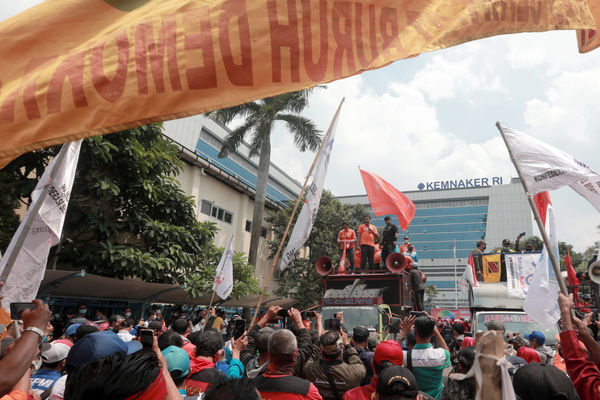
[0,143,68,286]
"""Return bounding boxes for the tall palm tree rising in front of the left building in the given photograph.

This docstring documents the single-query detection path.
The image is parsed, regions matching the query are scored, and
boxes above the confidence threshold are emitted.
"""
[209,89,321,266]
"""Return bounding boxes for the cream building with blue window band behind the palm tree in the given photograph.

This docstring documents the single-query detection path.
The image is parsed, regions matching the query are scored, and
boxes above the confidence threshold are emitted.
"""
[164,115,302,293]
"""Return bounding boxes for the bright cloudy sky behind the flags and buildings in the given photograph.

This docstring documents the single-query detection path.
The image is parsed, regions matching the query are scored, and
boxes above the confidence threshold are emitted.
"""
[0,0,600,251]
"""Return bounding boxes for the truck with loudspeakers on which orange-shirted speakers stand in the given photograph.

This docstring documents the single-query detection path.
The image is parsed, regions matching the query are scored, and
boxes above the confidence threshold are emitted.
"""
[316,253,413,340]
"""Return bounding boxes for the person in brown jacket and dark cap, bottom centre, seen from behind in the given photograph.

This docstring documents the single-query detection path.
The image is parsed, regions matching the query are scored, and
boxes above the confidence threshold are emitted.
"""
[301,329,366,400]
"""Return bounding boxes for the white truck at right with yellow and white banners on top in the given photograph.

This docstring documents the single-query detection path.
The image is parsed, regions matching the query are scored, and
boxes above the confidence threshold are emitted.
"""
[469,282,559,346]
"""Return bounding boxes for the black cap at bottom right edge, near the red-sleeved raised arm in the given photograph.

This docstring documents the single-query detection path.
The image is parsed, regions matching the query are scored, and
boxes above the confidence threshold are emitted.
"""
[513,363,577,400]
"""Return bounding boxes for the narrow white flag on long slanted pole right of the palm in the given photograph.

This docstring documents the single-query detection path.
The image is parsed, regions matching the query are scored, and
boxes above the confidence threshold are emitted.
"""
[279,118,337,271]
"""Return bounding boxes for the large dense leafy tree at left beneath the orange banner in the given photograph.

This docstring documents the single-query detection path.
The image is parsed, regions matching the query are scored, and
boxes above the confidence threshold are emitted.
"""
[0,124,258,296]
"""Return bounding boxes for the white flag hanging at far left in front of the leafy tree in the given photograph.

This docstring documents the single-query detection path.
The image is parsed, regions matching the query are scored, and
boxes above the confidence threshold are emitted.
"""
[0,140,81,309]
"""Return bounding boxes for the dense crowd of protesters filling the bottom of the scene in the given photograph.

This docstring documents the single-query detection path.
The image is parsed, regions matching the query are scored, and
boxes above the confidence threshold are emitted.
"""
[0,294,600,400]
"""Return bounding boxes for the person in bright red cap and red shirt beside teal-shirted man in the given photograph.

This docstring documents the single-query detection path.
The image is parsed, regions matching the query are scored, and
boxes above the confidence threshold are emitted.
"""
[343,340,404,400]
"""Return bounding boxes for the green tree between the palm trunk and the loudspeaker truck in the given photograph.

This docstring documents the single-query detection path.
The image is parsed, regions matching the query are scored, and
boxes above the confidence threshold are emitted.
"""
[267,190,367,308]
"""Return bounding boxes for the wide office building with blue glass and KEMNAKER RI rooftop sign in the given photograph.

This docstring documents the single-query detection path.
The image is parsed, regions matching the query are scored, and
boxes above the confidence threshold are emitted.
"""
[338,177,533,308]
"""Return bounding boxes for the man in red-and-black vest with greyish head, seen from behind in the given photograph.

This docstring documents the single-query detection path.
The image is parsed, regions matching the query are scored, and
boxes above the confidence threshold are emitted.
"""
[254,329,322,400]
